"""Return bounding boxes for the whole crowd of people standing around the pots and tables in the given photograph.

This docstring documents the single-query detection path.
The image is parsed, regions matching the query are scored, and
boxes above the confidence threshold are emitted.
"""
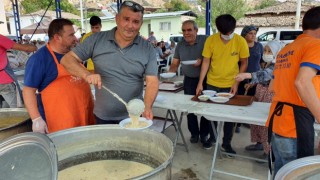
[0,1,320,177]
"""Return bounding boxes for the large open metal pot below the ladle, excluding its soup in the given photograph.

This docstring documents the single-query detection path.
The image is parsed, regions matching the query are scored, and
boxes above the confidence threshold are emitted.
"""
[48,125,174,179]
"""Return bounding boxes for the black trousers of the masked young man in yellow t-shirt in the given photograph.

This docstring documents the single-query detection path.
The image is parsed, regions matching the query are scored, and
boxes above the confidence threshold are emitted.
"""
[207,85,234,145]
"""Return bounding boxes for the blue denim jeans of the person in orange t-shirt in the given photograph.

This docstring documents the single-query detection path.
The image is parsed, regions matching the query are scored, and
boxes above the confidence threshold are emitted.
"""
[271,133,297,176]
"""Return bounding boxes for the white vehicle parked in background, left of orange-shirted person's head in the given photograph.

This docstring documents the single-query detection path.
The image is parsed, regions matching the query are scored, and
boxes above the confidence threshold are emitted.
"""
[257,29,302,46]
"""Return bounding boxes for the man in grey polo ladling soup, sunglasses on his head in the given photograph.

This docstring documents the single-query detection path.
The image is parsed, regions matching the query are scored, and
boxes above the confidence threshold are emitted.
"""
[61,1,158,124]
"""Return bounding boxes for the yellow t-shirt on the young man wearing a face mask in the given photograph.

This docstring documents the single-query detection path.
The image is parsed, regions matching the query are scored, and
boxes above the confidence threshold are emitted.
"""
[202,33,249,88]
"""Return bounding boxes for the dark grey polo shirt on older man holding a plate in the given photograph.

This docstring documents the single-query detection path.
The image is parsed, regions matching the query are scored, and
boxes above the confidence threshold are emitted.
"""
[173,35,207,78]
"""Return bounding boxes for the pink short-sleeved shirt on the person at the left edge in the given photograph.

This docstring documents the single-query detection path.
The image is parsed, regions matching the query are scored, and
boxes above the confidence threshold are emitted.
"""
[0,34,15,84]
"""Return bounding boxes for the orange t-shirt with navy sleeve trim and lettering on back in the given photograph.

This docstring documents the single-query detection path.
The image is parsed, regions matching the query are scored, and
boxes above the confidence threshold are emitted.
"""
[267,34,320,138]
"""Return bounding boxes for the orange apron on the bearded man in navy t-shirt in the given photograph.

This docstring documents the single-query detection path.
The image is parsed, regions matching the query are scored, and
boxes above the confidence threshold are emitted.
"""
[41,44,95,133]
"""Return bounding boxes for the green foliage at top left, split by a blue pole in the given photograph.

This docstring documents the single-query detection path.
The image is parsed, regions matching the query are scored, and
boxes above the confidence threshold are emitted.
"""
[21,0,80,15]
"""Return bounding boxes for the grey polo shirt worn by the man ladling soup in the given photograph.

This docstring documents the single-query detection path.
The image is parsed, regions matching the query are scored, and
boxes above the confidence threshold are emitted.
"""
[72,28,158,120]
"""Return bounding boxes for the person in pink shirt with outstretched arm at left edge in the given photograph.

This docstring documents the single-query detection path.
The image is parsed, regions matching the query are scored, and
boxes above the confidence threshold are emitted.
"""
[0,34,37,108]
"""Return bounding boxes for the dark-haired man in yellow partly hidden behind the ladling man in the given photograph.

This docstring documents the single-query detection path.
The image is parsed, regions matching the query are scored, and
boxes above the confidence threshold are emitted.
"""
[80,16,102,73]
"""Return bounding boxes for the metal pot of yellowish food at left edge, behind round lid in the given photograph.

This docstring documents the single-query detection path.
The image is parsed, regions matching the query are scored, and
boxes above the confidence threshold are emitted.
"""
[0,108,32,141]
